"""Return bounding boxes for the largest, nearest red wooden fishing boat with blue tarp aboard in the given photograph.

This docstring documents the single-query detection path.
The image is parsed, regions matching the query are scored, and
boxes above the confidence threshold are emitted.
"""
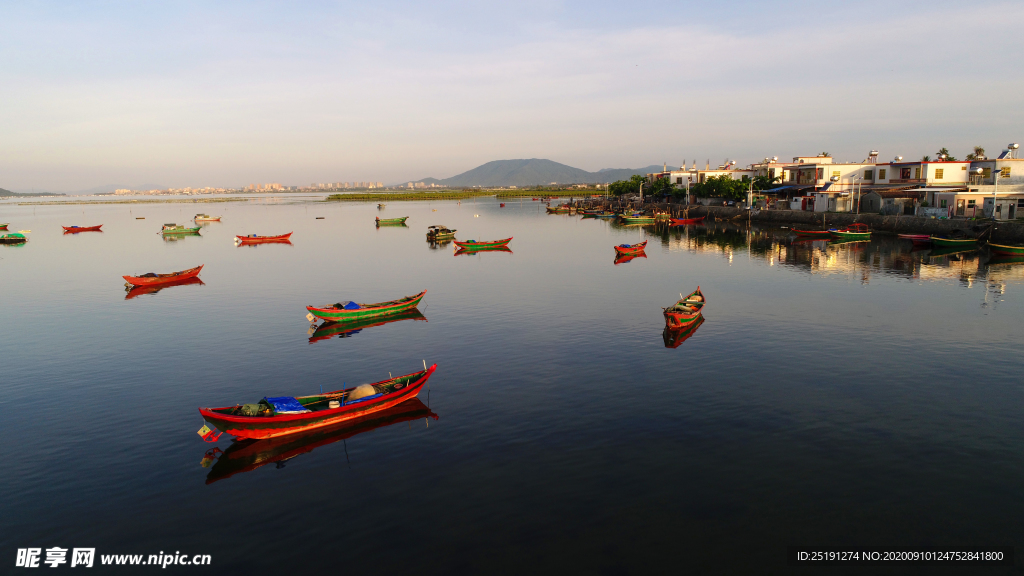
[199,364,437,439]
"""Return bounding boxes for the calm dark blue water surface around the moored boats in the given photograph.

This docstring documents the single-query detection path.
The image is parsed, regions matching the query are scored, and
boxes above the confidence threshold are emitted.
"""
[0,199,1024,574]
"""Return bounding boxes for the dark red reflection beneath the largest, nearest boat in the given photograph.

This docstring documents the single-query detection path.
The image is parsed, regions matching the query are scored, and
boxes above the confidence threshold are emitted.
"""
[201,398,438,484]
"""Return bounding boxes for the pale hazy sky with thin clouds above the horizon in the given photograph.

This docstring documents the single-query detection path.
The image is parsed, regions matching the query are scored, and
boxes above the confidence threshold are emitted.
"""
[0,0,1024,192]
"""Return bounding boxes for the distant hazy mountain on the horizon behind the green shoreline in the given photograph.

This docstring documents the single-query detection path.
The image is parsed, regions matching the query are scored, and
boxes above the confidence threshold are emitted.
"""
[414,158,662,188]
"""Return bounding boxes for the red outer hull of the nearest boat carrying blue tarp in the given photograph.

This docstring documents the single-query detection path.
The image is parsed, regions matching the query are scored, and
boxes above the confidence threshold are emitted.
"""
[199,364,437,439]
